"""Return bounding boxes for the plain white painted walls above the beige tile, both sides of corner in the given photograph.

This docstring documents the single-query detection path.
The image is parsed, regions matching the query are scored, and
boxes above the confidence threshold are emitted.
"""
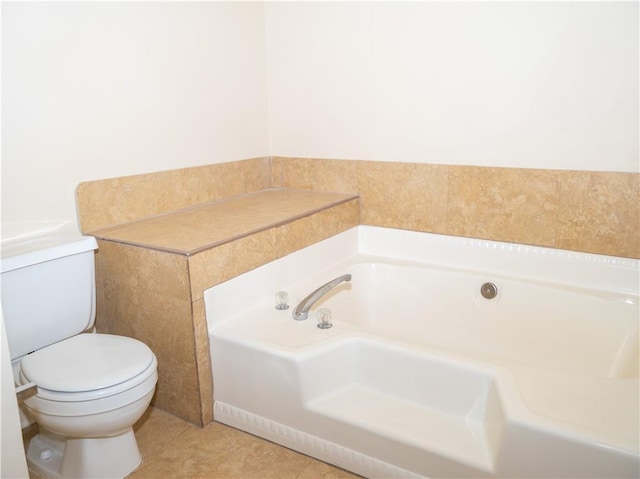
[2,1,639,239]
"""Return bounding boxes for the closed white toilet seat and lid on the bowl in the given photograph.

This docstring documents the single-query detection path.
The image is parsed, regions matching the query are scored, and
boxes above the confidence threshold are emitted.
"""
[20,333,157,402]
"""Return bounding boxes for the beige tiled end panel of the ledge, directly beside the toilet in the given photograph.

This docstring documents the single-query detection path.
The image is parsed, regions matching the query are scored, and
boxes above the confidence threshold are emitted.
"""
[91,241,202,424]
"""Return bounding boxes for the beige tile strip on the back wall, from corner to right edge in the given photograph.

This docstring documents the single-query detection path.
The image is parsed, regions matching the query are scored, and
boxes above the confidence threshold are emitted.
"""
[271,157,640,258]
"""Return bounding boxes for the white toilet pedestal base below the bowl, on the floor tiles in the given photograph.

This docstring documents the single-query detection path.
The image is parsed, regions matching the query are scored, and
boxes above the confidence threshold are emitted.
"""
[27,428,142,479]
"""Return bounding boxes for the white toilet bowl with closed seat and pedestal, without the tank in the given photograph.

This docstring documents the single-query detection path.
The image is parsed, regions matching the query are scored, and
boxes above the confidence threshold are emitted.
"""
[20,333,157,478]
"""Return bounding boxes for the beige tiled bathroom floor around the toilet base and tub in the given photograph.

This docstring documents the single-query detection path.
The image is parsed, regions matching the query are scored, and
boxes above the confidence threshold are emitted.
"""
[24,408,360,479]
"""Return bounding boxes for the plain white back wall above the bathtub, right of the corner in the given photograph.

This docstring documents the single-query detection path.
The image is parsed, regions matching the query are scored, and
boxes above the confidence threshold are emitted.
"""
[266,2,639,172]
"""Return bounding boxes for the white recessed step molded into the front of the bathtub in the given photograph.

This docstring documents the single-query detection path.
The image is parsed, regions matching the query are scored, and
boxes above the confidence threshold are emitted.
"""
[299,339,504,470]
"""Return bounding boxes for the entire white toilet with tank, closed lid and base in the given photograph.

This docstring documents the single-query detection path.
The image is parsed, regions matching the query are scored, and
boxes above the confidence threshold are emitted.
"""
[0,236,158,478]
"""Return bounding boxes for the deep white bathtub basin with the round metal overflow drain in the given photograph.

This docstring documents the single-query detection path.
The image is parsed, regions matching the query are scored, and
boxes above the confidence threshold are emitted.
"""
[332,258,638,378]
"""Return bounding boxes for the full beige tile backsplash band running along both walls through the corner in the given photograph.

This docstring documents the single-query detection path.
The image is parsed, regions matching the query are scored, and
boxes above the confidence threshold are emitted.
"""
[76,157,640,258]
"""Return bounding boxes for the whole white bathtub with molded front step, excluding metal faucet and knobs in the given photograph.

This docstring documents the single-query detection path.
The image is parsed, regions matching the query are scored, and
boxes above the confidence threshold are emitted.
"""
[205,226,640,478]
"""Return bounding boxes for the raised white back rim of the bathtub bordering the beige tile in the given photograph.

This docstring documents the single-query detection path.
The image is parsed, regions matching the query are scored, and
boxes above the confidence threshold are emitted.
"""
[208,225,640,332]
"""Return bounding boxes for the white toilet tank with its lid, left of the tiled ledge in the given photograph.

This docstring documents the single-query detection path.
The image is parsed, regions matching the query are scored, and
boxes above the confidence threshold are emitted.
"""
[0,236,98,360]
